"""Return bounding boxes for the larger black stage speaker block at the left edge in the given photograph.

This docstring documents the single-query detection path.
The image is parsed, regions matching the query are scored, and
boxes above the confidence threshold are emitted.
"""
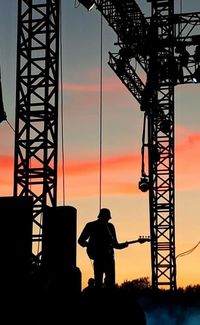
[0,196,33,281]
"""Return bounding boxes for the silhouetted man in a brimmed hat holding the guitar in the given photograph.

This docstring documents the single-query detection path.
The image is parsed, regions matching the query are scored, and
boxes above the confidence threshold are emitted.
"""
[78,208,128,288]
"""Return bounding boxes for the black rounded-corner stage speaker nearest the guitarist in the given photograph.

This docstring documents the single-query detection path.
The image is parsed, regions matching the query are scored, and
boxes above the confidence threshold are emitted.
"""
[42,206,77,272]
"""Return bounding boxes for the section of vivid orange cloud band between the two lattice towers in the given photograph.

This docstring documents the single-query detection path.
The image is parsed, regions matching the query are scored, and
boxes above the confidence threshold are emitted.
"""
[58,154,140,197]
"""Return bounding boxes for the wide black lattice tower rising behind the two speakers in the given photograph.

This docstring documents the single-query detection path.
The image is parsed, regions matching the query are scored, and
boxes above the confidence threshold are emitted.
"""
[14,0,59,256]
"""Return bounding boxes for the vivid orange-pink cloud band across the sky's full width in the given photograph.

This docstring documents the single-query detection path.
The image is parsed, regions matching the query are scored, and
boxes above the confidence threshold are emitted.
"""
[0,129,200,197]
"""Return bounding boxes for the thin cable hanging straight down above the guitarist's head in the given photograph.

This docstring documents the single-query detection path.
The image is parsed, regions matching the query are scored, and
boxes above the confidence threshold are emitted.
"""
[99,14,103,209]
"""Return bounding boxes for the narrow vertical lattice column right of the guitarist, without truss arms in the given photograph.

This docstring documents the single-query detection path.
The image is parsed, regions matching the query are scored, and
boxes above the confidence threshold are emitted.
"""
[147,0,176,290]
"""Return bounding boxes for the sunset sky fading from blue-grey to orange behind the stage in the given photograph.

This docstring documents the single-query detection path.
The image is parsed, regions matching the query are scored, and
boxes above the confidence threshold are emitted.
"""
[0,0,200,287]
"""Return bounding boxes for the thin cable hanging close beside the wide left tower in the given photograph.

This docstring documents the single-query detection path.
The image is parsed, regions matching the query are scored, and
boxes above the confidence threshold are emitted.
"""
[59,0,65,205]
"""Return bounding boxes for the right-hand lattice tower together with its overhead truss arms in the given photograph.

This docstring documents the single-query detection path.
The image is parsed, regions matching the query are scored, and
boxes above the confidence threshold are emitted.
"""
[79,0,200,290]
